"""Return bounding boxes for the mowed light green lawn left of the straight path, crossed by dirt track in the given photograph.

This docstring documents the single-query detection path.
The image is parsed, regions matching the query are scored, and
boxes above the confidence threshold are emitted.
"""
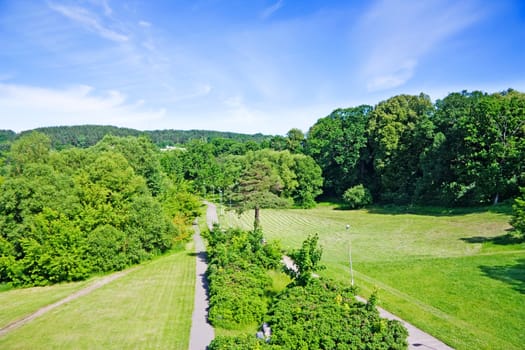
[0,246,195,350]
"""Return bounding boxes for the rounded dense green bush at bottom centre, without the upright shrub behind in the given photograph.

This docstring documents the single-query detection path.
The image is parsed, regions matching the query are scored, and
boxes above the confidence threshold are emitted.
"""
[268,279,408,349]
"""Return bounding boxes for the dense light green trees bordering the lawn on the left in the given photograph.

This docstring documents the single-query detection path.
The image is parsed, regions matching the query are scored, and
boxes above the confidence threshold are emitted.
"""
[0,132,201,286]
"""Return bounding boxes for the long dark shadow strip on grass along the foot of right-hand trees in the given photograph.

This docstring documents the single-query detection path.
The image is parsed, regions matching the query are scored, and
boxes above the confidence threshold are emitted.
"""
[356,204,512,216]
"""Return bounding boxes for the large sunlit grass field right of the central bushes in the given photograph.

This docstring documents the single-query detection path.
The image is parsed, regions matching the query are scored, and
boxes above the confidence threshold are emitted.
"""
[221,205,525,349]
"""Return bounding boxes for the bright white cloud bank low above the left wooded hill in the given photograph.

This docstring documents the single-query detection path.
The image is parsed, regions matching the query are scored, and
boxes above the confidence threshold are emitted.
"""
[0,84,166,131]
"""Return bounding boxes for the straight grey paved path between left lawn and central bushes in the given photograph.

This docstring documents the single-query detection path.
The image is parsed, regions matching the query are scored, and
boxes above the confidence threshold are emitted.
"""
[190,203,218,350]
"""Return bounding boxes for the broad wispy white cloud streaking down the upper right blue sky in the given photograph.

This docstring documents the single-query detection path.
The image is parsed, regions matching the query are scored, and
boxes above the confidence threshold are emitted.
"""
[356,0,483,91]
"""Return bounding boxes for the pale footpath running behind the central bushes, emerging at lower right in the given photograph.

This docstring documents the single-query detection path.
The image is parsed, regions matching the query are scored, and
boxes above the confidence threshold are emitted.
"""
[203,203,453,350]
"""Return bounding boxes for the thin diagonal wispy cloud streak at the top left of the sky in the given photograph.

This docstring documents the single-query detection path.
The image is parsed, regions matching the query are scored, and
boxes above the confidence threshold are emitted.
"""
[49,2,129,42]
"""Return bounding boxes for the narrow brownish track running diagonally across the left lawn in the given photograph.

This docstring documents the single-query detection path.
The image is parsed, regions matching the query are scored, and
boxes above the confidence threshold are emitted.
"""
[0,268,131,337]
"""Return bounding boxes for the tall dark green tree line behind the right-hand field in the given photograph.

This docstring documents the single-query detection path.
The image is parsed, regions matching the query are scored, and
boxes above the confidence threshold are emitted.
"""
[304,90,525,206]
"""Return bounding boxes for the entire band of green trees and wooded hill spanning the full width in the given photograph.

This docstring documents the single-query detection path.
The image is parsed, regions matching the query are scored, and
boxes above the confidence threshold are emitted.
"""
[0,89,525,285]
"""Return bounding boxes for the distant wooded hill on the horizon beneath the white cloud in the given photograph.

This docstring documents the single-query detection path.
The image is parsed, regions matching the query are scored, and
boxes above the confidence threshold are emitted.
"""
[15,125,272,149]
